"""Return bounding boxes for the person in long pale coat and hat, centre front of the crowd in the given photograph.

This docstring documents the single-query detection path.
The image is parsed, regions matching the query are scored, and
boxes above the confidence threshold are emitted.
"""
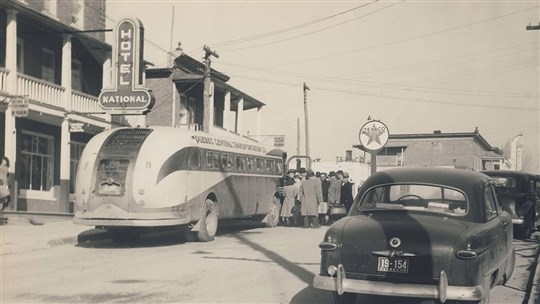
[299,170,322,228]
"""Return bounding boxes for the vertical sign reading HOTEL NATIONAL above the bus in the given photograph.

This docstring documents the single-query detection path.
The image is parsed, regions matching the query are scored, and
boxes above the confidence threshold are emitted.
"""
[98,19,154,115]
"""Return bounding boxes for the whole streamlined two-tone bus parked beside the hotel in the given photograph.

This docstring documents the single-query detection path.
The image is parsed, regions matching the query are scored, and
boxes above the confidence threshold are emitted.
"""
[74,127,292,241]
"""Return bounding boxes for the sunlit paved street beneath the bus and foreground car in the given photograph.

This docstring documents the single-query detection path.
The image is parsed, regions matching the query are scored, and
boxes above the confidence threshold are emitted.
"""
[0,215,539,304]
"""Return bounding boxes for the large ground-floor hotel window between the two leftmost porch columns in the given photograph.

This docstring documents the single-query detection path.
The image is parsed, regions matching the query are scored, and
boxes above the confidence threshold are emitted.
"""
[20,131,54,191]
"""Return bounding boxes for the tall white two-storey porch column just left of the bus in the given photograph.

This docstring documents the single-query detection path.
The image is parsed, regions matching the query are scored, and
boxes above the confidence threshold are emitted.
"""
[57,34,72,212]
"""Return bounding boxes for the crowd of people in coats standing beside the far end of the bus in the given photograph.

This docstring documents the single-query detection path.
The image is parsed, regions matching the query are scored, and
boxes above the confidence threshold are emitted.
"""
[280,170,354,228]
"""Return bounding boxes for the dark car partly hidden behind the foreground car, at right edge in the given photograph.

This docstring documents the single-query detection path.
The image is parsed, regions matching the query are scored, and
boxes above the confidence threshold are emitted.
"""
[482,170,539,239]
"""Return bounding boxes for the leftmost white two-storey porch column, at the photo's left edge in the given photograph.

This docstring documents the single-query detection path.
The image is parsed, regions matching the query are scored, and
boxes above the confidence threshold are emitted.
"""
[4,9,18,198]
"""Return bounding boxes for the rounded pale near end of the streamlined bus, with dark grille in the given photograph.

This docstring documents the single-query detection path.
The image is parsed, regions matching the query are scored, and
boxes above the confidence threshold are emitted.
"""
[74,128,190,227]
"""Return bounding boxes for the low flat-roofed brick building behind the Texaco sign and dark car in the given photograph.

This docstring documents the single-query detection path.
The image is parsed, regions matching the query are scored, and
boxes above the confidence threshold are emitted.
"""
[355,129,511,170]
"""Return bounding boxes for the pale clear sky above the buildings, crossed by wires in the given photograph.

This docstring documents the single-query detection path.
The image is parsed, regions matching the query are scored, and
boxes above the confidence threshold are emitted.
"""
[106,0,540,173]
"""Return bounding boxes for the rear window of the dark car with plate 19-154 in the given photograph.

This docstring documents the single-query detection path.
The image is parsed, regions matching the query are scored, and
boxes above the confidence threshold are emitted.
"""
[358,184,468,216]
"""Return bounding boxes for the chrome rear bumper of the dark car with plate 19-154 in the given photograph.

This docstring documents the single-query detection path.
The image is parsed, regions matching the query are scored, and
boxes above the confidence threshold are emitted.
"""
[313,265,489,303]
